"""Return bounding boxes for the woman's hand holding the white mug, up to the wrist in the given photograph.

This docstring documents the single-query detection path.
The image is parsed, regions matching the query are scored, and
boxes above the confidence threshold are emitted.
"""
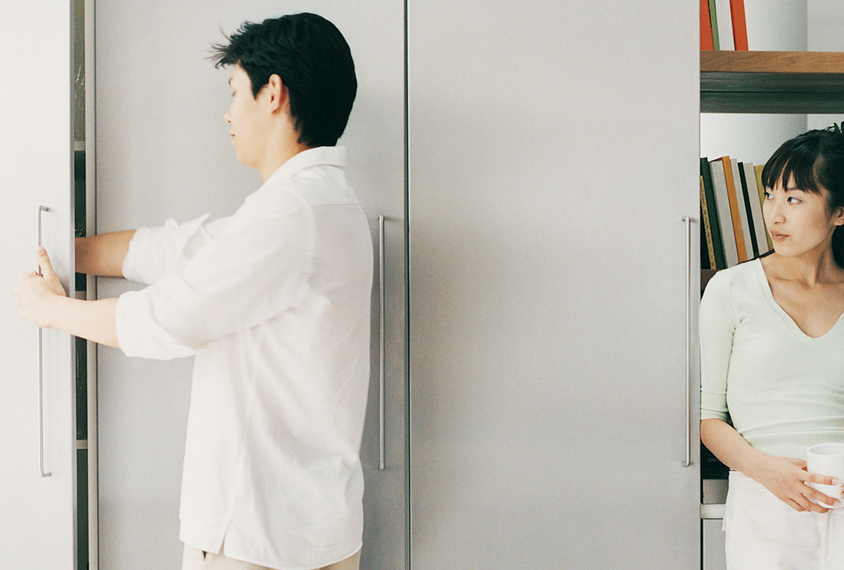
[745,455,841,513]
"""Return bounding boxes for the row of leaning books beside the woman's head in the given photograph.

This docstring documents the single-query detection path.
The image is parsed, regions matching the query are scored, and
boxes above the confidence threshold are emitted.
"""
[700,156,773,269]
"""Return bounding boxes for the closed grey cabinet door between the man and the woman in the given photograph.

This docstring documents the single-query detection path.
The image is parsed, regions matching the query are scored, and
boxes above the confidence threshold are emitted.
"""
[408,0,700,570]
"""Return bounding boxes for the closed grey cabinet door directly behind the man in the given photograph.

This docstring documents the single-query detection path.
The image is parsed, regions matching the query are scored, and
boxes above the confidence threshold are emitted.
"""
[96,0,407,570]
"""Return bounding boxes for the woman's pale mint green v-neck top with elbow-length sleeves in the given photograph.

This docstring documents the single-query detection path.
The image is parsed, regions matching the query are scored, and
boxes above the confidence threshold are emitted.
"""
[699,259,844,459]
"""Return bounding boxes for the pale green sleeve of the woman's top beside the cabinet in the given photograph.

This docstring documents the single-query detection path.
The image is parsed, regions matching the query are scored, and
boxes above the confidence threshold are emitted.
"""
[699,274,736,421]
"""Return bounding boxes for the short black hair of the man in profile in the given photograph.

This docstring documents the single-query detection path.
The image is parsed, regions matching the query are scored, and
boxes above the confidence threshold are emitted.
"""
[212,13,357,147]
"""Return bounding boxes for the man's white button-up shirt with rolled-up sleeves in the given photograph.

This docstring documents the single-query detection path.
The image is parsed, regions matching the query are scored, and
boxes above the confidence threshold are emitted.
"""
[116,147,372,568]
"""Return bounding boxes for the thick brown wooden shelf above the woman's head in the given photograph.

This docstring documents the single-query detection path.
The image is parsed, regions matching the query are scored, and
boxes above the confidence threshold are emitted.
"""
[700,51,844,114]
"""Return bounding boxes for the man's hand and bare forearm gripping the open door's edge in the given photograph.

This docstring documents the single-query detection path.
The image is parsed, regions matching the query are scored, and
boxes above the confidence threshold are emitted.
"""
[15,247,119,348]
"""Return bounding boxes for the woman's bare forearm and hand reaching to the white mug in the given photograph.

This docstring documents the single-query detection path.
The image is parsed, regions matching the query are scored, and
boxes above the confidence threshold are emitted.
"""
[700,419,841,513]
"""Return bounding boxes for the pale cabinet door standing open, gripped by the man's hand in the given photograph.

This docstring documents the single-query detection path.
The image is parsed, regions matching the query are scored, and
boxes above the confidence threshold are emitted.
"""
[0,0,76,570]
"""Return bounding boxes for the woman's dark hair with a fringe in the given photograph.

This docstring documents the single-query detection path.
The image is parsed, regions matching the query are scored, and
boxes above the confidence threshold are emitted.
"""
[762,129,844,267]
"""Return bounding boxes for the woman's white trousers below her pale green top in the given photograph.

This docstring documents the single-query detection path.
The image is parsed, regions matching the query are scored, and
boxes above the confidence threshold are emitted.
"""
[724,471,844,570]
